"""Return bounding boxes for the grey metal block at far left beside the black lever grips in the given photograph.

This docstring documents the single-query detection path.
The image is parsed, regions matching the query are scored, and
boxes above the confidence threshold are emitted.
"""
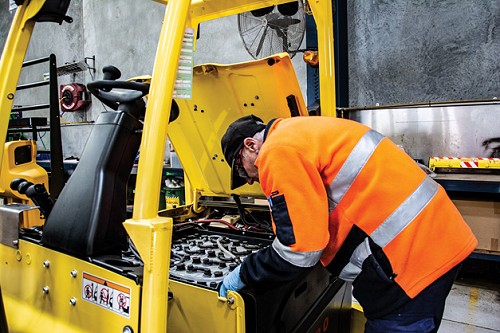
[0,203,38,249]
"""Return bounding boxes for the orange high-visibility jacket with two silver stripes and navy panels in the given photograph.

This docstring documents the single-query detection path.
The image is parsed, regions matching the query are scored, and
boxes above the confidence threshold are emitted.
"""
[255,117,477,316]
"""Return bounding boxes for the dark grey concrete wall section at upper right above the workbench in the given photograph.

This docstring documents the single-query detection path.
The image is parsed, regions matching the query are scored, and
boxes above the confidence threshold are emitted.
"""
[348,0,500,107]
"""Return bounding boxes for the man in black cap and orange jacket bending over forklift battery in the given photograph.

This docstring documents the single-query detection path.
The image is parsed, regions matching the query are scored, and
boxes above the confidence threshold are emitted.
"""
[219,115,477,332]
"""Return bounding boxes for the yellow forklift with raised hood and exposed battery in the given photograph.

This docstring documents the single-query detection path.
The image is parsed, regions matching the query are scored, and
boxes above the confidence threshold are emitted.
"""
[0,0,351,333]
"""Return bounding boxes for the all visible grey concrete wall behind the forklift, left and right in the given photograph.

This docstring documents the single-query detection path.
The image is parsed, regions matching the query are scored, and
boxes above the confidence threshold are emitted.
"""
[0,0,500,156]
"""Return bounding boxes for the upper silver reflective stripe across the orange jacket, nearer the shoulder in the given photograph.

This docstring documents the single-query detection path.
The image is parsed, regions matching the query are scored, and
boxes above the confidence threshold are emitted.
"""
[327,130,384,213]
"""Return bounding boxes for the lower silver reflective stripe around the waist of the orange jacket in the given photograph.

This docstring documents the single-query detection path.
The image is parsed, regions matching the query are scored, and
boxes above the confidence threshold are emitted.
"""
[339,177,438,282]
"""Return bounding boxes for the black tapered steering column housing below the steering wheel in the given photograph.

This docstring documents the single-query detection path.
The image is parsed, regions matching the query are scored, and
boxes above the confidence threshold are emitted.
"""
[42,100,145,256]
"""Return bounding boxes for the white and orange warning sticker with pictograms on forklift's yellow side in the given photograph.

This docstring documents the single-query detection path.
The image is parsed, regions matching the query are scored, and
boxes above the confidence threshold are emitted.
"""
[82,272,130,318]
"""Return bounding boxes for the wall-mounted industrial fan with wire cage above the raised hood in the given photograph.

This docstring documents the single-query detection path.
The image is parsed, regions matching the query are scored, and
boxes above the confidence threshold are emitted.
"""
[238,1,306,59]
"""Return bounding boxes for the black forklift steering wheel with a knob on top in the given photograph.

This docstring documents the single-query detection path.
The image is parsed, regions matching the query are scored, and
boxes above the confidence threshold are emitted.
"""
[87,66,149,110]
